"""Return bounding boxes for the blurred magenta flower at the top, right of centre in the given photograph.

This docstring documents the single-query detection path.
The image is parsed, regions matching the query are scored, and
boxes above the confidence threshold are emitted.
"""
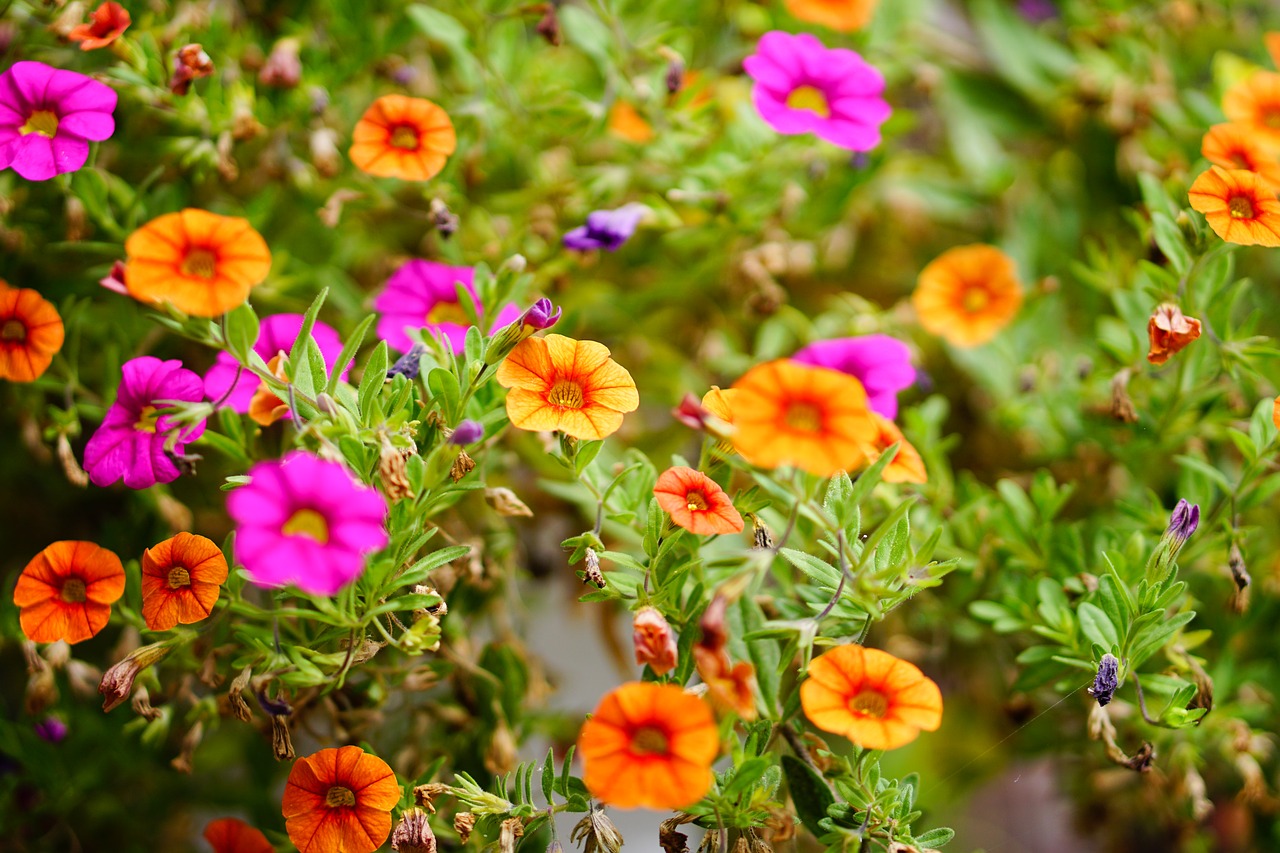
[742,29,892,151]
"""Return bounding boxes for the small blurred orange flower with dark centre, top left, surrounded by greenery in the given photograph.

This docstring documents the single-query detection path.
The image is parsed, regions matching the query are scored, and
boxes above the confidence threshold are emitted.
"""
[348,95,458,181]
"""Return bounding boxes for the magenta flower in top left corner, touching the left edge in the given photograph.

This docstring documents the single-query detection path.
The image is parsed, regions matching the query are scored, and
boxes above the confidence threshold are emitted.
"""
[0,61,115,181]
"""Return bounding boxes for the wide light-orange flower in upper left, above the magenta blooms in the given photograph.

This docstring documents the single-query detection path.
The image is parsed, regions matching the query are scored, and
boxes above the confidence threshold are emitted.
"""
[124,207,271,316]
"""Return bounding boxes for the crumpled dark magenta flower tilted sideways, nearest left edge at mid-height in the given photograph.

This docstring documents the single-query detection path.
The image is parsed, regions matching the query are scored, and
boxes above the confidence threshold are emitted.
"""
[84,356,205,489]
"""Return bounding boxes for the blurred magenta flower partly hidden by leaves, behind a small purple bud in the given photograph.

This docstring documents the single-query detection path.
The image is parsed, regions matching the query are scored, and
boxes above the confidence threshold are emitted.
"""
[374,259,520,352]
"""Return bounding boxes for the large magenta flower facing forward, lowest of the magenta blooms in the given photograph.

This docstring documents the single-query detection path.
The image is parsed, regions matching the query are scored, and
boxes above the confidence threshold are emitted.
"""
[227,451,388,596]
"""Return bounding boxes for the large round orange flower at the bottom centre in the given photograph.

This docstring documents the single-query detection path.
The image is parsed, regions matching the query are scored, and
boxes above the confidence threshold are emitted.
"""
[577,681,719,809]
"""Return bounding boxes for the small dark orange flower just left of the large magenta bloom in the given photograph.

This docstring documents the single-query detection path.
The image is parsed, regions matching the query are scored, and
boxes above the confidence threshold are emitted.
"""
[142,533,227,631]
